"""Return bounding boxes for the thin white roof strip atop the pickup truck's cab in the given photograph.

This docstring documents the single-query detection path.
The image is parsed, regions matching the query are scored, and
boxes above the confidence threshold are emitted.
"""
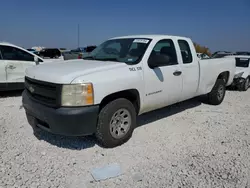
[111,34,190,39]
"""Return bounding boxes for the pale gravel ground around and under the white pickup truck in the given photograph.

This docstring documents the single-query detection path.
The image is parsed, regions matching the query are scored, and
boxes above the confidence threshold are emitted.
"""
[0,90,250,188]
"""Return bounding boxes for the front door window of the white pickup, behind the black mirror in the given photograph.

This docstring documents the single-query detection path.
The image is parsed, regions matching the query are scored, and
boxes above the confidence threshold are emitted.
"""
[149,39,178,66]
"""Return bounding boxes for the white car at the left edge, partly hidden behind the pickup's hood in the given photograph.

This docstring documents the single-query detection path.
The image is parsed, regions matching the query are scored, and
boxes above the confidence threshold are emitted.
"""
[0,42,53,91]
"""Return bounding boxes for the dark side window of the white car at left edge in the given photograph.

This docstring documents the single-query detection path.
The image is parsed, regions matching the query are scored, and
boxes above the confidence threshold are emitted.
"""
[1,46,34,61]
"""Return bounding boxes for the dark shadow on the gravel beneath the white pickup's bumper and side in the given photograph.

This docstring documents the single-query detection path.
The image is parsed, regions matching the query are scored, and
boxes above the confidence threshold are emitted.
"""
[34,98,202,150]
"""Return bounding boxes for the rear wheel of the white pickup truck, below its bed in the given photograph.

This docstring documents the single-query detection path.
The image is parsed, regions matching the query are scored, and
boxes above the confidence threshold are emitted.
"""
[208,79,226,105]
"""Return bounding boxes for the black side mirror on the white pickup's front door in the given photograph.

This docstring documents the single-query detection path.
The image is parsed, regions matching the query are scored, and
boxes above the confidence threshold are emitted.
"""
[148,54,170,69]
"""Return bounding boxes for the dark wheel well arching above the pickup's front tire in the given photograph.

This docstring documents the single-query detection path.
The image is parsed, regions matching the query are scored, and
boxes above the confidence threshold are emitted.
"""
[100,89,140,114]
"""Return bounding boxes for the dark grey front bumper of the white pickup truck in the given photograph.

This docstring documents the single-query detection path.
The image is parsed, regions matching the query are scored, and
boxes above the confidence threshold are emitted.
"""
[22,91,99,136]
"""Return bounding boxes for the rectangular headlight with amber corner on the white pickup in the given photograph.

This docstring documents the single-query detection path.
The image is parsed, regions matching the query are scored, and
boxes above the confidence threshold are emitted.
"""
[61,83,94,106]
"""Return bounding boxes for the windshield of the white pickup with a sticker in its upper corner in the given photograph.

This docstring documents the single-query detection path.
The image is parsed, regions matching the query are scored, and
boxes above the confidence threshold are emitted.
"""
[83,38,151,64]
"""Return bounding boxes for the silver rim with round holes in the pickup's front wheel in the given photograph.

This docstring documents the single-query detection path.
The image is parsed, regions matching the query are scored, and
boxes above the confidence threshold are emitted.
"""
[110,108,131,139]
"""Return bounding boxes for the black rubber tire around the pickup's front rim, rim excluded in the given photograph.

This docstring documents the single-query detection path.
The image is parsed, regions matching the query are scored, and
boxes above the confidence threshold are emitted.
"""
[95,98,137,148]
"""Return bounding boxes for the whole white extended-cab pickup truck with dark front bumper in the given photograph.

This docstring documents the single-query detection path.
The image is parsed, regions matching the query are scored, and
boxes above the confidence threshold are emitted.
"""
[22,35,235,147]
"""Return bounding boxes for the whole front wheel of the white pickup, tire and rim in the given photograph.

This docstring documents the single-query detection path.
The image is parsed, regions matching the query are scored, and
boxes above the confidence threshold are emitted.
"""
[95,98,136,148]
